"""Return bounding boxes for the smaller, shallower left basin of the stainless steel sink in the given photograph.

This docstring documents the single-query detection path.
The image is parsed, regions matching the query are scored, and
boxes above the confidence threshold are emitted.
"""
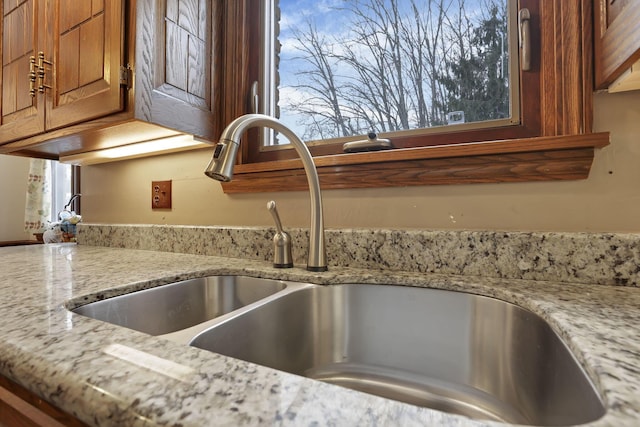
[72,276,286,335]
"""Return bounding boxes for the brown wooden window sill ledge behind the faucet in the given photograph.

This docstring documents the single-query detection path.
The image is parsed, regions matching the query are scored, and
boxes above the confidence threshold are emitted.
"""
[222,132,609,193]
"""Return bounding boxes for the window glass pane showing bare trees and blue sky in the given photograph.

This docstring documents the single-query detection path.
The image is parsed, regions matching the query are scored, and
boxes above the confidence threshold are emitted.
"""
[261,0,519,144]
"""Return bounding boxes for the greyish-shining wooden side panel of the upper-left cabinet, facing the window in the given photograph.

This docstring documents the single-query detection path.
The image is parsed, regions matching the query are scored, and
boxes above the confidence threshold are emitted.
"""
[135,0,218,139]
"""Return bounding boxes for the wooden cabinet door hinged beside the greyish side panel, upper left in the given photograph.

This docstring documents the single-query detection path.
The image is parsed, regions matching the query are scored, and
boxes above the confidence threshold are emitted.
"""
[44,0,124,130]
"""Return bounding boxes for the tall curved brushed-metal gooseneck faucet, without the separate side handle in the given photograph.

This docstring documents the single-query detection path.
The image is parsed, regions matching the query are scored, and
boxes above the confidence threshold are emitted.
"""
[204,114,327,271]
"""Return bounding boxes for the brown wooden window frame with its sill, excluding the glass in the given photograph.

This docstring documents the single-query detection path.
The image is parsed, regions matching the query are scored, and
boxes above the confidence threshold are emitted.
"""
[215,0,608,192]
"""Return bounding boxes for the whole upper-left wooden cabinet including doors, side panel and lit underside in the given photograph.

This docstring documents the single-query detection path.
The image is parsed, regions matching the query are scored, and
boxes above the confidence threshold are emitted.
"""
[0,0,216,158]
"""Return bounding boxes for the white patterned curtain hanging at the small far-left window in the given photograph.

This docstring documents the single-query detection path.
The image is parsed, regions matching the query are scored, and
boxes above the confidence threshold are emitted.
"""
[24,159,51,233]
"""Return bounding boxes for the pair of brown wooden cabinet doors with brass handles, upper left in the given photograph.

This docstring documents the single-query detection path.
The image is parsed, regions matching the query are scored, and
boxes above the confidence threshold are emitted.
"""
[0,0,124,143]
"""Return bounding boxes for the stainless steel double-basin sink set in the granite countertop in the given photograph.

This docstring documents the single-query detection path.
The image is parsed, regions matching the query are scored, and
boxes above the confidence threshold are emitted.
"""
[73,276,605,426]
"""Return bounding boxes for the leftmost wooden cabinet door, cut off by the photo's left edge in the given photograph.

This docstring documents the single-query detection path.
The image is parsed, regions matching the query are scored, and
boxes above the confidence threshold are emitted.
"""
[0,0,44,144]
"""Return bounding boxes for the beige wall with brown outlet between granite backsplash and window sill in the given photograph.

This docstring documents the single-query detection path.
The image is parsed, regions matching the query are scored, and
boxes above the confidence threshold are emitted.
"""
[82,91,640,232]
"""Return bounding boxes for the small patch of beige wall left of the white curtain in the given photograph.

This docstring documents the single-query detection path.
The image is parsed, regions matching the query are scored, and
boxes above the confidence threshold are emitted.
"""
[0,155,31,241]
